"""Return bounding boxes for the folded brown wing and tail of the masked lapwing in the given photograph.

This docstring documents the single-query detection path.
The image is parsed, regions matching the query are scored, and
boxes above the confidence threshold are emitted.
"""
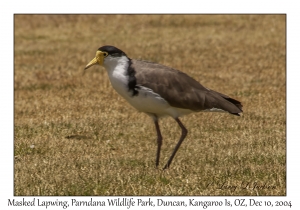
[131,60,242,115]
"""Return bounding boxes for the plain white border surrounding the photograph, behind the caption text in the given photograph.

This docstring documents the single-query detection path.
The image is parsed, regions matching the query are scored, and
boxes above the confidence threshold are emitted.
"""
[0,0,300,209]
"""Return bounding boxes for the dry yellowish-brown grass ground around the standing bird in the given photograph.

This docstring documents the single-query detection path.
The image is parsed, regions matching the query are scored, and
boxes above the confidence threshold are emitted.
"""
[14,15,286,195]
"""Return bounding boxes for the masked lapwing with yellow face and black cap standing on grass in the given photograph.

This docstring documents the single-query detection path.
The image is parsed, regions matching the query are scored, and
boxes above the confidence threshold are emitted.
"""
[84,45,243,169]
